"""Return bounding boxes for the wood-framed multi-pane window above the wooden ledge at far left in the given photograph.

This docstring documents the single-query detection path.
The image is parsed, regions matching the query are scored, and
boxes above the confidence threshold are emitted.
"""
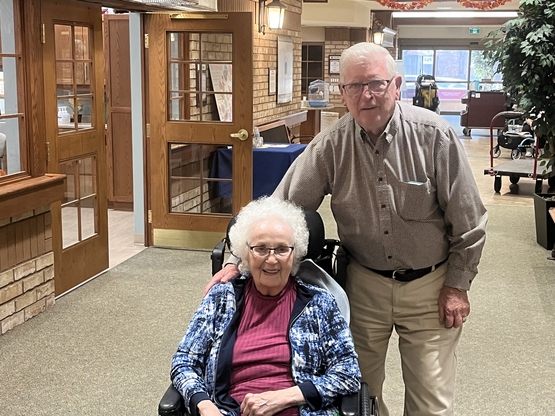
[0,0,27,175]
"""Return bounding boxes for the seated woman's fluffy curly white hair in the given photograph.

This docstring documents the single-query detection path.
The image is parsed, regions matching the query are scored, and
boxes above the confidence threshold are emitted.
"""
[229,197,308,274]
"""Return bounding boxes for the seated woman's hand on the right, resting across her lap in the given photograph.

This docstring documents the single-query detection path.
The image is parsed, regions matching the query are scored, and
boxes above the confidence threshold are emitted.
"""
[241,386,305,416]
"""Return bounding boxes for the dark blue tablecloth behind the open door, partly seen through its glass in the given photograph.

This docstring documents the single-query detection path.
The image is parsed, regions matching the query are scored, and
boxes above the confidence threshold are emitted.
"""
[210,144,306,199]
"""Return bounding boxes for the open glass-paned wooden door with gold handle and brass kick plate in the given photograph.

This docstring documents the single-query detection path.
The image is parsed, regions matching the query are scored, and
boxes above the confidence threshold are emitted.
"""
[146,12,253,248]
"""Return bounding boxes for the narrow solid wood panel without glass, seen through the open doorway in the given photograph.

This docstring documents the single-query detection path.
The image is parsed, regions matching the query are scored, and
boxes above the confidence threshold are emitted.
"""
[103,14,133,211]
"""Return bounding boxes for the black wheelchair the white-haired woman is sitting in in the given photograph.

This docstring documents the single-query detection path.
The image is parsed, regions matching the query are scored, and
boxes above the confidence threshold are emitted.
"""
[158,211,378,416]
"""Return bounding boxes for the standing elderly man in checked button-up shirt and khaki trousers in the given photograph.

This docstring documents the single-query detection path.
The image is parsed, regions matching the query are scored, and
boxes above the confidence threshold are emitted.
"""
[213,43,487,416]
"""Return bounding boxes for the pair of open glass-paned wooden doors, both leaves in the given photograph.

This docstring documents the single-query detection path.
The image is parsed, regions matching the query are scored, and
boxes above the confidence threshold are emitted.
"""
[41,0,253,295]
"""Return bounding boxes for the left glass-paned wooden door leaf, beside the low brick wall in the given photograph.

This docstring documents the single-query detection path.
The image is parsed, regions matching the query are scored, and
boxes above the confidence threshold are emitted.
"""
[42,0,109,295]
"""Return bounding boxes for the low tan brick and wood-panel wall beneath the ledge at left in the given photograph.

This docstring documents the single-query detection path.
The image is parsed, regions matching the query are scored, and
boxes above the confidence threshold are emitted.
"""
[0,207,55,335]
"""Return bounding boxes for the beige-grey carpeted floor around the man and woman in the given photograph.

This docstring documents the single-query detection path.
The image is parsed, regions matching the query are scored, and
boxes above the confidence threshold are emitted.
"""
[0,205,555,416]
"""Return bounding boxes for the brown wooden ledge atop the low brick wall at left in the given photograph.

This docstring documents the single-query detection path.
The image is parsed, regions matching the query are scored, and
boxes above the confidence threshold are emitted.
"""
[0,174,66,220]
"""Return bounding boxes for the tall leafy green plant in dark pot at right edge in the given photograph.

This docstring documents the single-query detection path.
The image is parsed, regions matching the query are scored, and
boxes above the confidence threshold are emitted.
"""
[485,0,555,250]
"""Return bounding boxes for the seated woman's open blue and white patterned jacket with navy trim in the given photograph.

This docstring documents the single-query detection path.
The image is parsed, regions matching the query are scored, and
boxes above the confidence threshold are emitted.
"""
[171,276,361,416]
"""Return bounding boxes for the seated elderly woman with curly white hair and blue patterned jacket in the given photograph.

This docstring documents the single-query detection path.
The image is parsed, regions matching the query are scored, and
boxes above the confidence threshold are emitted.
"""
[171,197,360,416]
